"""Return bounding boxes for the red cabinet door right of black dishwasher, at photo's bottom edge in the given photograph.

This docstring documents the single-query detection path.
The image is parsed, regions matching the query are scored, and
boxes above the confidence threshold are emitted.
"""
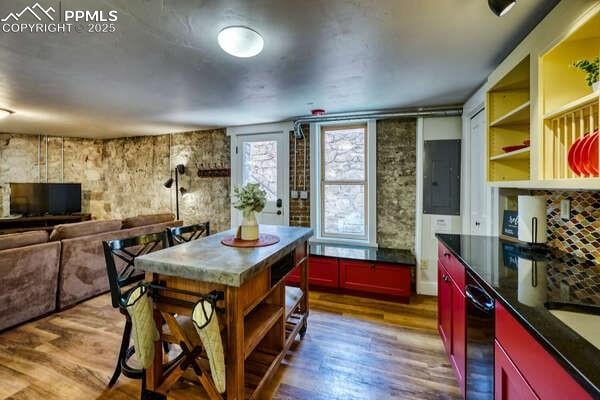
[494,342,539,400]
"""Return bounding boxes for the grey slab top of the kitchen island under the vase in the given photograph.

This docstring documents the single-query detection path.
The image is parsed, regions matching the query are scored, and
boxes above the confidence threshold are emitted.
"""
[135,225,313,287]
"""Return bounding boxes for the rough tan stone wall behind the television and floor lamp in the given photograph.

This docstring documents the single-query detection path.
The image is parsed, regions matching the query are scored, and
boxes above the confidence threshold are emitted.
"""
[0,129,230,232]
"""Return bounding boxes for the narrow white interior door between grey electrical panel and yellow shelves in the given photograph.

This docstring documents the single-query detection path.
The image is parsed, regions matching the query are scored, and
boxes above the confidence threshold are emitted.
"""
[468,110,487,235]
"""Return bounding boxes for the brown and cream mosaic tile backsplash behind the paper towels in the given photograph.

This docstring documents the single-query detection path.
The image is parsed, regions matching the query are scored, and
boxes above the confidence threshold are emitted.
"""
[544,191,600,265]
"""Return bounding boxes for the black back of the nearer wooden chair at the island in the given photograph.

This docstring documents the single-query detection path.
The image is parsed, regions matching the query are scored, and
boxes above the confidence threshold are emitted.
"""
[102,231,168,308]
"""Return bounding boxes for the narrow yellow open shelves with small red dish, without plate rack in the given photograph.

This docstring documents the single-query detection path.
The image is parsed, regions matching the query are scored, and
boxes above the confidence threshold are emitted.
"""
[486,56,531,182]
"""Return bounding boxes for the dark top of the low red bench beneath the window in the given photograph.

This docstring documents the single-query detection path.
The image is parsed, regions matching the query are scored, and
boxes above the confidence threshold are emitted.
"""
[310,243,417,266]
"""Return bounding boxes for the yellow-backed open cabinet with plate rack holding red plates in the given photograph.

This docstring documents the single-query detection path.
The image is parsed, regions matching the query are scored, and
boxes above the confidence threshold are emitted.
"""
[539,13,600,181]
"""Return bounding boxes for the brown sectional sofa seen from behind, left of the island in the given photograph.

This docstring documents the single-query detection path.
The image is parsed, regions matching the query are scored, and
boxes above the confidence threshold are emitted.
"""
[0,214,182,330]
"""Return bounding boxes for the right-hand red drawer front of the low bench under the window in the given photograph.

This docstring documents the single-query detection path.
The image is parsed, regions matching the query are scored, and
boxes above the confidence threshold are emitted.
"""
[340,261,410,297]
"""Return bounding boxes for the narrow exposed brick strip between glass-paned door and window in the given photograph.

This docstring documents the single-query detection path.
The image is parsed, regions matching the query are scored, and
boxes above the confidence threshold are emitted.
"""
[290,125,310,226]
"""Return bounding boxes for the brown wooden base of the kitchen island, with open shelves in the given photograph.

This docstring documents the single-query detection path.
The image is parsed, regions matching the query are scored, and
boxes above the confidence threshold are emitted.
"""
[142,240,309,400]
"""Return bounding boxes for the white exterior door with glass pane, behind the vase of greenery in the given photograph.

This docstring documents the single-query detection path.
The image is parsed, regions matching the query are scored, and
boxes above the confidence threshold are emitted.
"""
[232,133,288,226]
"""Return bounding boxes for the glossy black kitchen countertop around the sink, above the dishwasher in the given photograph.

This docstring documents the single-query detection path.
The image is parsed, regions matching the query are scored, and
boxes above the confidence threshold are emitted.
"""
[436,234,600,398]
